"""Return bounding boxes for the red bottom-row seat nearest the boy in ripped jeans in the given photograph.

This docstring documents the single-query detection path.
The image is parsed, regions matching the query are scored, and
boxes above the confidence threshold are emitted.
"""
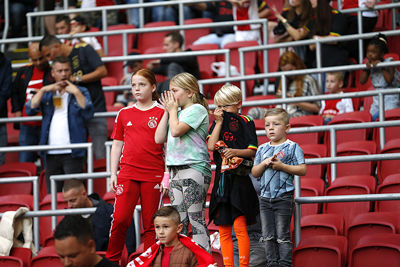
[293,235,347,267]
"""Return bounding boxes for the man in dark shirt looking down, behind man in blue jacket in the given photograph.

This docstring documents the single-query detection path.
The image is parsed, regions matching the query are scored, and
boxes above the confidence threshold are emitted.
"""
[40,35,107,159]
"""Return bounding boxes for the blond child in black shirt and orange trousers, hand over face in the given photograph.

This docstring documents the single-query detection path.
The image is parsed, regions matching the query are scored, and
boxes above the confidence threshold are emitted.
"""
[207,85,259,266]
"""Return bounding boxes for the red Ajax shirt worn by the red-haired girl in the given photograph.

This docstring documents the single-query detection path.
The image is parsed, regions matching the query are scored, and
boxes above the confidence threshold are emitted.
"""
[111,102,165,182]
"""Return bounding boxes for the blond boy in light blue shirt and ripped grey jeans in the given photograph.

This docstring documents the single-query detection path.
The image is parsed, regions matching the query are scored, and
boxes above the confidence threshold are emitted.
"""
[251,108,307,267]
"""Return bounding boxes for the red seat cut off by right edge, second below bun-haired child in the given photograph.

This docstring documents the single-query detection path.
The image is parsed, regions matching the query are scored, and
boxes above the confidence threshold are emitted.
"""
[377,137,400,183]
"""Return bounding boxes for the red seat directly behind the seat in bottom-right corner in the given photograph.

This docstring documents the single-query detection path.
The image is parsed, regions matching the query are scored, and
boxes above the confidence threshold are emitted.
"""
[346,212,397,258]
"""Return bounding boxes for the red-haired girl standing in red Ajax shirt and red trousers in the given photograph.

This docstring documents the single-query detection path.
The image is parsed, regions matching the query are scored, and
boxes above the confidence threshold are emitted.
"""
[106,69,165,262]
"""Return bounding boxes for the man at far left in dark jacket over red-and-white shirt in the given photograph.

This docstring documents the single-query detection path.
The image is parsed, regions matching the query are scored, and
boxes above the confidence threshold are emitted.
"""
[12,42,53,162]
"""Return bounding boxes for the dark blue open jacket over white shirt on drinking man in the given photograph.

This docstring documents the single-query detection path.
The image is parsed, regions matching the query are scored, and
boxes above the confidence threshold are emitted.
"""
[25,86,94,157]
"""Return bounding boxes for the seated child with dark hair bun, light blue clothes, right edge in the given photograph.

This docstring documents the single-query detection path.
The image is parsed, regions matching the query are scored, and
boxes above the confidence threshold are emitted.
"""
[360,34,399,121]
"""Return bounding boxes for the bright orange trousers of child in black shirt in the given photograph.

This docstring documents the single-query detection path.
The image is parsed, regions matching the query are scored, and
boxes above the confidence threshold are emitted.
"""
[219,216,250,266]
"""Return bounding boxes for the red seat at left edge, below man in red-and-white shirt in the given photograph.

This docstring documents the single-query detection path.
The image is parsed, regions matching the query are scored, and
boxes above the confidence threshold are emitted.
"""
[0,162,37,196]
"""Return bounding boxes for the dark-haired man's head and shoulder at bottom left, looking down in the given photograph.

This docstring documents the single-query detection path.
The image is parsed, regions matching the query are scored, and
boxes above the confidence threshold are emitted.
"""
[54,215,119,267]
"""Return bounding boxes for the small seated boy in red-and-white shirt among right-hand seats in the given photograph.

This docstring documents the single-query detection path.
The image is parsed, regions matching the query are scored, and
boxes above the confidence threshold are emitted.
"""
[319,71,354,124]
